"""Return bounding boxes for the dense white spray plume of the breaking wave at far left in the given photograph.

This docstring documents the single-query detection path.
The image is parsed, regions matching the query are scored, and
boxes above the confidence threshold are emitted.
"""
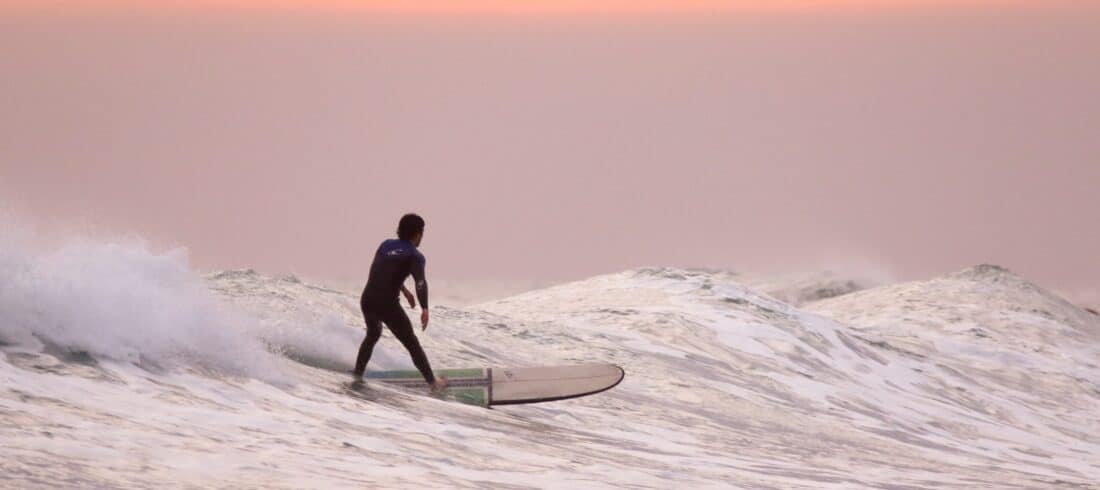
[0,231,288,375]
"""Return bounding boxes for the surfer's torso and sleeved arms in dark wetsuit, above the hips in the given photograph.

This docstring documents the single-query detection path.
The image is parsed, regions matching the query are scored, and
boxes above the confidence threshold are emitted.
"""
[362,239,428,308]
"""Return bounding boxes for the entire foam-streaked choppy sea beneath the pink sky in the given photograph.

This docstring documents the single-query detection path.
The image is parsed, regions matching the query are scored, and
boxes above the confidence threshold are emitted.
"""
[0,234,1100,489]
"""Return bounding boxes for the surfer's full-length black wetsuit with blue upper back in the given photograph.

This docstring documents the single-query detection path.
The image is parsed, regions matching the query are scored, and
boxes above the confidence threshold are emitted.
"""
[355,239,436,383]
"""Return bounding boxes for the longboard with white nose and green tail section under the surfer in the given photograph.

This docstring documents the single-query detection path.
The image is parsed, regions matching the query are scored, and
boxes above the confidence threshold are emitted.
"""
[366,364,626,407]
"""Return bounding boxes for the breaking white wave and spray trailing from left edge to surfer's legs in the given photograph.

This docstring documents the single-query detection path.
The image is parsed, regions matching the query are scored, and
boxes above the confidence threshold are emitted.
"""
[0,220,413,383]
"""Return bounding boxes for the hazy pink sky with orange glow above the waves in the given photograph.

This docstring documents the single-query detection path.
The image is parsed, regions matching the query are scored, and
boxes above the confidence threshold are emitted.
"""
[0,2,1100,297]
